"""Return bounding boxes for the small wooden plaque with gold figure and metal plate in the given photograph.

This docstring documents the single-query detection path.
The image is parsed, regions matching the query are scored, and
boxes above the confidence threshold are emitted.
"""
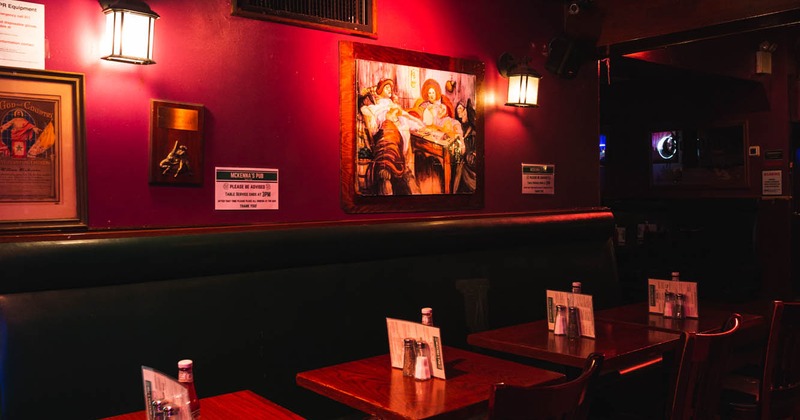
[150,100,204,186]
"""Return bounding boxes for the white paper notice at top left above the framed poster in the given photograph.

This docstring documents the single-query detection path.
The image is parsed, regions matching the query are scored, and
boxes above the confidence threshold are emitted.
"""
[0,0,44,70]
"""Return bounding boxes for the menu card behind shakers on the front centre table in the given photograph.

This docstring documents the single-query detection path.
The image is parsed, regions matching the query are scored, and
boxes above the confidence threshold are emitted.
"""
[386,318,446,379]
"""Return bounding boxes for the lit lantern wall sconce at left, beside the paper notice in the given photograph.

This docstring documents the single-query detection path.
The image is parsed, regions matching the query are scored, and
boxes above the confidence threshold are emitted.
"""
[100,0,159,64]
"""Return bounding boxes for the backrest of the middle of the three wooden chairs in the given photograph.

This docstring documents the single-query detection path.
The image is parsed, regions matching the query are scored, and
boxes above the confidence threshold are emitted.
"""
[667,314,742,420]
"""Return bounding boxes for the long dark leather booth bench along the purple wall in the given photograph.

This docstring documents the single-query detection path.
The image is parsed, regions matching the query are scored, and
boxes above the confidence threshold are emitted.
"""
[0,208,618,420]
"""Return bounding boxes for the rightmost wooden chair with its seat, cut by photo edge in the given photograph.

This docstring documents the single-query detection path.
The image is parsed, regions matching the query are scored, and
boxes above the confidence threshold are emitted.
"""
[723,301,800,419]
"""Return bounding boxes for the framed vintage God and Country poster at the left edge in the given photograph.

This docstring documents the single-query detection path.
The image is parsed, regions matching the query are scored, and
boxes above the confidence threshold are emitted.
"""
[0,67,87,232]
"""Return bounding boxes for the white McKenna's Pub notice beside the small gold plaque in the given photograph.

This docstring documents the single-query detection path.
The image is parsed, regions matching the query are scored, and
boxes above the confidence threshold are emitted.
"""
[214,168,278,210]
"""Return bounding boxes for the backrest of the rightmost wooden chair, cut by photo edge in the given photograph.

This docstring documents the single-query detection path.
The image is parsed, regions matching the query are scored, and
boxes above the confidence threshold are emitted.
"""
[760,301,800,419]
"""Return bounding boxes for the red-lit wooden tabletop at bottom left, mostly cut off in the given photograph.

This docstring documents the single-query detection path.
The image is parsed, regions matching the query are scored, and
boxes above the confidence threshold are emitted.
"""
[100,391,303,420]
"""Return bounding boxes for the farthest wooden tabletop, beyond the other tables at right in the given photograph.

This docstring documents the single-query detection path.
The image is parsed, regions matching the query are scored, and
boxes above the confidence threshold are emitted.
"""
[594,302,766,333]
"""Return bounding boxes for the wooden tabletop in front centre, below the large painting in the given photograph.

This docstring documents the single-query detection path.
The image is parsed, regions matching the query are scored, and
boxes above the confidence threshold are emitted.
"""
[297,346,564,419]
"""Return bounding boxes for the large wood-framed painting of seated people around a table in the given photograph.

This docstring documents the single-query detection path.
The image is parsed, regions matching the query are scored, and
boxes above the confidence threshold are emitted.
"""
[339,41,485,213]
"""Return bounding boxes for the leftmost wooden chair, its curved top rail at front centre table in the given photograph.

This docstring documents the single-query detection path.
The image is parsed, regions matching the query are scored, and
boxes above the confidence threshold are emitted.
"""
[489,353,603,420]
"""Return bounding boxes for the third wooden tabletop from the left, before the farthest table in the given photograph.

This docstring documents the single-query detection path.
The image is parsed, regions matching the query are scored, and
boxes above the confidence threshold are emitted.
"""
[467,318,680,373]
